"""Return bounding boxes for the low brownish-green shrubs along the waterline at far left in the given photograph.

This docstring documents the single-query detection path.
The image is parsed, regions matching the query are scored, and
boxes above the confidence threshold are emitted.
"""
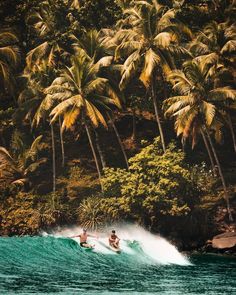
[0,192,72,235]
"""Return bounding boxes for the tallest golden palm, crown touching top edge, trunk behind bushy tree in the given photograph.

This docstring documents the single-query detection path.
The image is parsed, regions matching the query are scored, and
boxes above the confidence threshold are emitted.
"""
[114,0,190,151]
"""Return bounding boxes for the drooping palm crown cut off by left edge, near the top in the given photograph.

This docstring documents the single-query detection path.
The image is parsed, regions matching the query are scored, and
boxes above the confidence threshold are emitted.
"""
[0,31,20,94]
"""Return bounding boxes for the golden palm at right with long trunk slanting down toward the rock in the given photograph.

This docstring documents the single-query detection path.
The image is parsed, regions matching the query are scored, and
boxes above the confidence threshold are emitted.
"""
[165,60,236,220]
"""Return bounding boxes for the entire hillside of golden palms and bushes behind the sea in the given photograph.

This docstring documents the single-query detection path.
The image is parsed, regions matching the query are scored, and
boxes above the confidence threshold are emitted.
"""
[0,0,236,253]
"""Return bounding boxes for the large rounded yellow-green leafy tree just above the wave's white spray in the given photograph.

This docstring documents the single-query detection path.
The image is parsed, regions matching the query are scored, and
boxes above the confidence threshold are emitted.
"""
[99,138,197,223]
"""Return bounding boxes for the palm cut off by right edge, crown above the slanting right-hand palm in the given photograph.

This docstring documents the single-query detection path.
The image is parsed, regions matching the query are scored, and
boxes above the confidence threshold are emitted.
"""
[190,21,236,152]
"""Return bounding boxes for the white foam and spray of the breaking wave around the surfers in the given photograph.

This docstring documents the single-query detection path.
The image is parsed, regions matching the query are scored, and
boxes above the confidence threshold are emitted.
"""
[50,224,191,266]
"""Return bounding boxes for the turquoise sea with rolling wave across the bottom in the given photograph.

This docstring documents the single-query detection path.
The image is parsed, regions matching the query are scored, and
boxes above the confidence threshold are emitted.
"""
[0,232,236,295]
